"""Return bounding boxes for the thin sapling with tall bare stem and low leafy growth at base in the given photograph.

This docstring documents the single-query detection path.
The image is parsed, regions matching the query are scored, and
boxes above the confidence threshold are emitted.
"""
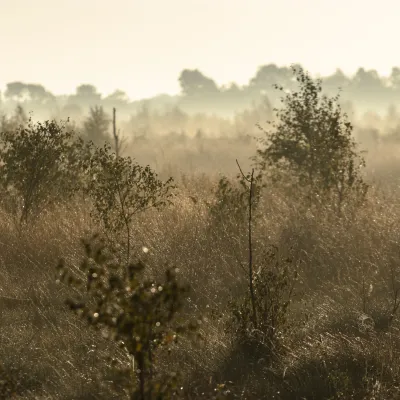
[228,160,297,345]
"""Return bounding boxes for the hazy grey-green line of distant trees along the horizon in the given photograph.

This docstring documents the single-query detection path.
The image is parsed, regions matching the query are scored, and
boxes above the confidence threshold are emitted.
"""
[0,64,400,119]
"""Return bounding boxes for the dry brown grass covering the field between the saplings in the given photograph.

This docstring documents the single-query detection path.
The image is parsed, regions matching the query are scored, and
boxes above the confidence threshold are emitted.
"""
[0,139,400,400]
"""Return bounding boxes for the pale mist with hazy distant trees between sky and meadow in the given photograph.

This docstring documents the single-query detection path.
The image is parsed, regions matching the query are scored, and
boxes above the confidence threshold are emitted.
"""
[0,64,400,173]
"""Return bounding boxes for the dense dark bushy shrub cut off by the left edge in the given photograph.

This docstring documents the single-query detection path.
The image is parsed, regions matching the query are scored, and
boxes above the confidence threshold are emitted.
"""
[0,118,84,222]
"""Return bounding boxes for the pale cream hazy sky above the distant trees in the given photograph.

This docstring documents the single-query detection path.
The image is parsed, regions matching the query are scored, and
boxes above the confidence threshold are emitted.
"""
[0,0,400,99]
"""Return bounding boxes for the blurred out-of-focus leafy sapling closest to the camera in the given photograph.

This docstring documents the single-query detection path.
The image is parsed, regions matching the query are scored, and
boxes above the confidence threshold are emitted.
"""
[58,236,196,400]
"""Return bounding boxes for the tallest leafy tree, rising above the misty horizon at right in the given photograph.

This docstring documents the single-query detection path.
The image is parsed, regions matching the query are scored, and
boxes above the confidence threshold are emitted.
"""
[256,67,367,213]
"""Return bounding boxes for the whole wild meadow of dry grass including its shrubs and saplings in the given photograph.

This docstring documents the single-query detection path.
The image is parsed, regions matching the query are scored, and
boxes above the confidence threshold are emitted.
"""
[0,68,400,400]
